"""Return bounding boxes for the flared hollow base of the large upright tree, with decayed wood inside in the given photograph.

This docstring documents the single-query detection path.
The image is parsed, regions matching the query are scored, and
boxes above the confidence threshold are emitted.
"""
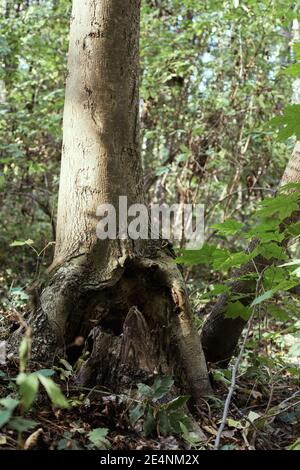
[10,248,212,403]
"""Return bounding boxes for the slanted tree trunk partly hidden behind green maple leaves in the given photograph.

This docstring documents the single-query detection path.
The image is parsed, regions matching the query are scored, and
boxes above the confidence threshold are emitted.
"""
[201,142,300,367]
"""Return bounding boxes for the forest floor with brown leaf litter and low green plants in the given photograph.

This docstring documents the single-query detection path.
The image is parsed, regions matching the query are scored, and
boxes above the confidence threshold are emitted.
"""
[0,306,300,450]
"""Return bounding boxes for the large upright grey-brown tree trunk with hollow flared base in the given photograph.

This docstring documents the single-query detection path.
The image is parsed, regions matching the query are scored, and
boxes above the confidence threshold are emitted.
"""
[8,0,211,401]
